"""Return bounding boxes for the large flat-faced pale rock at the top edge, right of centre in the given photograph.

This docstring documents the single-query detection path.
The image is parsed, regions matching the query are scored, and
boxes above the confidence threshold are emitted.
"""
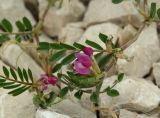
[84,0,143,26]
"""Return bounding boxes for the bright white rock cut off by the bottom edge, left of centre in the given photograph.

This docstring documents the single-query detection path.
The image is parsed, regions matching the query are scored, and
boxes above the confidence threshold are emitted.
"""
[35,109,71,118]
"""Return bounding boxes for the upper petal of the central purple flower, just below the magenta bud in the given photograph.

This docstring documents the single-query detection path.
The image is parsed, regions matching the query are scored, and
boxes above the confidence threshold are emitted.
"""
[75,52,92,68]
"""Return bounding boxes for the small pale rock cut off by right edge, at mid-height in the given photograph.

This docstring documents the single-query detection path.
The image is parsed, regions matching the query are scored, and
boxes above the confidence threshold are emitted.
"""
[153,63,160,86]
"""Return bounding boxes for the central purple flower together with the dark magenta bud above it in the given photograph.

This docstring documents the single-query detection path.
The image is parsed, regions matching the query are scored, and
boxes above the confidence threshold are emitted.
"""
[74,47,93,75]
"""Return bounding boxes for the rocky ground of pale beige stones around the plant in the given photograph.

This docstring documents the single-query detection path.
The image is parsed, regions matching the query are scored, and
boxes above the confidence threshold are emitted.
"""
[0,0,160,118]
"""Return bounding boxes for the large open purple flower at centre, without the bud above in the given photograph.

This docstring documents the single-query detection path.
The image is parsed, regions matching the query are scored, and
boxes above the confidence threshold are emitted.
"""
[73,52,92,75]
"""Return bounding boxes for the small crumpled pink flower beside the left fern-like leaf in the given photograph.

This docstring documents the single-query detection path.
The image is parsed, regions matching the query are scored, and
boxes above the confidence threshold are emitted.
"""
[41,74,58,90]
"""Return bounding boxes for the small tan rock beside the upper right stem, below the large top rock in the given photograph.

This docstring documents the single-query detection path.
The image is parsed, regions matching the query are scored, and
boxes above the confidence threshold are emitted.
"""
[118,24,137,46]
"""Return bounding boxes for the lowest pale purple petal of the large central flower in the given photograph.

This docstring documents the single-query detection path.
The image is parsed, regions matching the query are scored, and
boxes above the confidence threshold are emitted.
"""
[74,60,91,75]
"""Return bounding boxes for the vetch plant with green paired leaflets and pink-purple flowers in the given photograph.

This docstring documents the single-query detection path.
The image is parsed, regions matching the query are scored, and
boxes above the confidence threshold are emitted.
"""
[0,0,160,117]
